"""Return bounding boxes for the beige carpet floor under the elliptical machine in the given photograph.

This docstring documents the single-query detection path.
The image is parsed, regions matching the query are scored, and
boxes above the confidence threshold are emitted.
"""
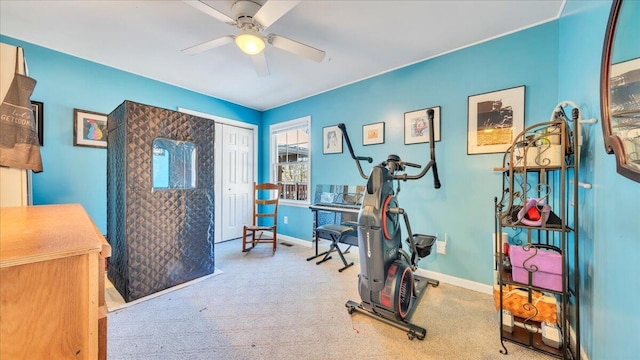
[107,240,550,360]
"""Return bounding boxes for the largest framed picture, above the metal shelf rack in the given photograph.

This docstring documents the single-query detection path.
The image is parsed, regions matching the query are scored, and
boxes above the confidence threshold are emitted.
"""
[467,85,525,155]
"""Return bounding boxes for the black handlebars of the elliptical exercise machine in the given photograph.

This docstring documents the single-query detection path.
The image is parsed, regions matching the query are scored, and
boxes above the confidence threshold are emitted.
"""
[338,109,441,189]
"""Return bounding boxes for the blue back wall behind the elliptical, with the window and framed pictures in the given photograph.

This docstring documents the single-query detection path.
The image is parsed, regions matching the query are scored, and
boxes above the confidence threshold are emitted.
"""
[261,22,558,284]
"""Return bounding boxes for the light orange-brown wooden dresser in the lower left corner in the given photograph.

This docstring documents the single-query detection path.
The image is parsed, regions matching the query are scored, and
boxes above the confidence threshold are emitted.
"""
[0,204,111,359]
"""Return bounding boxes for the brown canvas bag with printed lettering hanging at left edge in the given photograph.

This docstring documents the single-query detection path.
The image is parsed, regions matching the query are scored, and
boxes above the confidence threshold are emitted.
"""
[0,47,42,172]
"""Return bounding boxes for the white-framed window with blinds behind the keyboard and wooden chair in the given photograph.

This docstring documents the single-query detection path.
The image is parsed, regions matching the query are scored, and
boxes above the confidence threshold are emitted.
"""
[270,116,311,204]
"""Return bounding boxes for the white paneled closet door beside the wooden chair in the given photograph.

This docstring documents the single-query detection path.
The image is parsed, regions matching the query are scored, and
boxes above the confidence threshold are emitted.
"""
[216,124,255,242]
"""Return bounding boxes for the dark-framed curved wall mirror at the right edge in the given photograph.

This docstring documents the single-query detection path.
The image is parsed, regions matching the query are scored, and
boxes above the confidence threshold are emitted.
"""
[600,0,640,182]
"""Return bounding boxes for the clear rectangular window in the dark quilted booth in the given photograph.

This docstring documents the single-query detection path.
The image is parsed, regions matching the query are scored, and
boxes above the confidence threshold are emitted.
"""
[151,138,196,190]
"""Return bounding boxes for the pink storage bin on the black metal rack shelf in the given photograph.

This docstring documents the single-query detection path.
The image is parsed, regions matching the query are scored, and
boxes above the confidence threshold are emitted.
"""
[509,246,562,291]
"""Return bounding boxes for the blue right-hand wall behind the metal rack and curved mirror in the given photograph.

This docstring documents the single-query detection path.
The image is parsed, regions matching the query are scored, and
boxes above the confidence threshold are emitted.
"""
[558,1,640,359]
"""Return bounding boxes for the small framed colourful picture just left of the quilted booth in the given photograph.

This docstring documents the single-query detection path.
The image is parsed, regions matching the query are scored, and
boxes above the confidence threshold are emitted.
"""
[73,109,107,148]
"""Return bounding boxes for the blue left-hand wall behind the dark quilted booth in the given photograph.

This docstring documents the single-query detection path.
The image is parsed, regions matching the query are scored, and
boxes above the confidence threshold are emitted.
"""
[0,36,262,234]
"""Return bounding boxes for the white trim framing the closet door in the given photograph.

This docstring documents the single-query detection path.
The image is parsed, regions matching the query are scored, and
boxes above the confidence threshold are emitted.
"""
[178,107,258,242]
